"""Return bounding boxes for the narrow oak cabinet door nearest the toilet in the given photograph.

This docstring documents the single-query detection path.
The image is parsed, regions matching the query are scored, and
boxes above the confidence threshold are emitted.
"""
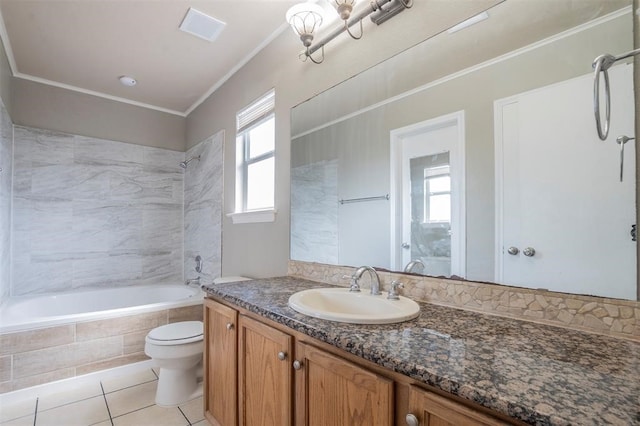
[204,299,238,426]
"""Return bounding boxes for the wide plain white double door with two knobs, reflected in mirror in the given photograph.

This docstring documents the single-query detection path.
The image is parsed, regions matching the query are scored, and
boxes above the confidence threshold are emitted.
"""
[495,65,636,299]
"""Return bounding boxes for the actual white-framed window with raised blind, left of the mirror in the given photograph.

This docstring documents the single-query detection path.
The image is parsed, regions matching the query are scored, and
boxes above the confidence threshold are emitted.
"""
[231,90,275,223]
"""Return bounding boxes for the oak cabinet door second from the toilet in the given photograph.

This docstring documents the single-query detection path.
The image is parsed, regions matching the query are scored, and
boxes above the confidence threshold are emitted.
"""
[238,315,293,426]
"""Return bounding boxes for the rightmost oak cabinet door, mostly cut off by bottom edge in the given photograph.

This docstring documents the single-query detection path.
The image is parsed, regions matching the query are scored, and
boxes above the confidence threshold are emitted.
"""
[407,386,508,426]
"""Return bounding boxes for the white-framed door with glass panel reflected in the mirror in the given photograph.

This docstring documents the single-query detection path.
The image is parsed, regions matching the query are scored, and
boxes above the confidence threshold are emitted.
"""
[391,112,465,277]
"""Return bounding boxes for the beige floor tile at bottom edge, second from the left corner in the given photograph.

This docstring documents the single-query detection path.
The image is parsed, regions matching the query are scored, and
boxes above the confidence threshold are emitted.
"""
[36,396,109,426]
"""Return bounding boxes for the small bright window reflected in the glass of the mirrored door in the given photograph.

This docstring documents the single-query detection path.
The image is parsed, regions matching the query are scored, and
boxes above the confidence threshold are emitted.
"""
[424,165,451,223]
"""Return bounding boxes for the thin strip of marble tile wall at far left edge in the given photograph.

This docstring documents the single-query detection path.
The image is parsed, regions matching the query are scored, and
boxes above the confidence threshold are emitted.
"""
[0,99,13,305]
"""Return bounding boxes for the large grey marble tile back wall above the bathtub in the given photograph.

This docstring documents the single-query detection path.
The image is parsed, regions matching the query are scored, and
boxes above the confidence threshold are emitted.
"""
[10,126,184,296]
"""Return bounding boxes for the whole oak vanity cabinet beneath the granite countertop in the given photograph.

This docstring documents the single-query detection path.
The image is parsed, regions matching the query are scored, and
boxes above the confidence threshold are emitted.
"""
[204,299,520,426]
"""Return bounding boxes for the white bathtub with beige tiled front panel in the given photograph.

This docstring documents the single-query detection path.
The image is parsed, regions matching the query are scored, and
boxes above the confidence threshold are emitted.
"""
[0,284,204,394]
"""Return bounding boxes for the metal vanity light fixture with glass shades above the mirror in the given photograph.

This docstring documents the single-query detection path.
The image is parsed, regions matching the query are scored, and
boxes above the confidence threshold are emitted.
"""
[286,0,413,64]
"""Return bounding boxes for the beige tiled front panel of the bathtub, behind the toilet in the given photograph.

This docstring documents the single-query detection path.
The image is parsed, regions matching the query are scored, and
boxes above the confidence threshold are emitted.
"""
[0,305,203,393]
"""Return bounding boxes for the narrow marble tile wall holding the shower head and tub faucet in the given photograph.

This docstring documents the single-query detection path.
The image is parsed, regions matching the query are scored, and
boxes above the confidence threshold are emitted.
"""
[184,131,224,284]
